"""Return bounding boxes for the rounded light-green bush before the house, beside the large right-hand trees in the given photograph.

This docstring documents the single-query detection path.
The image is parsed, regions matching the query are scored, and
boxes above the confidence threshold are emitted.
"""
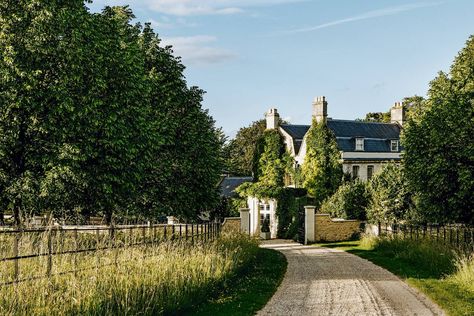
[367,163,412,222]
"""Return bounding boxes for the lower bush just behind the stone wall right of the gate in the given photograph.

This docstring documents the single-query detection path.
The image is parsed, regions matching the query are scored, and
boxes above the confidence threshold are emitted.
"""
[320,180,369,220]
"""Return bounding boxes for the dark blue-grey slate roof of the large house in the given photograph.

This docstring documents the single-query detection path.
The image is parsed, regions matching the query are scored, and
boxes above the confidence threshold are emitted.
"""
[281,119,402,154]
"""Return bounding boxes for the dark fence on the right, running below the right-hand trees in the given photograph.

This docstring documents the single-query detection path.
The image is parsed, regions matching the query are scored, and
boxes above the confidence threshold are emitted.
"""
[378,223,474,253]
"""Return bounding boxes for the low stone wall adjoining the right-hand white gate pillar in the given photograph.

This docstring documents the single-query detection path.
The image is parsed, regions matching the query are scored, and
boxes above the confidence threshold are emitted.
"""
[314,214,361,242]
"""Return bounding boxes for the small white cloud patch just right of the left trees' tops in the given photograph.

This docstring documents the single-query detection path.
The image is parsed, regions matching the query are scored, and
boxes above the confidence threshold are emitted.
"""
[162,35,236,65]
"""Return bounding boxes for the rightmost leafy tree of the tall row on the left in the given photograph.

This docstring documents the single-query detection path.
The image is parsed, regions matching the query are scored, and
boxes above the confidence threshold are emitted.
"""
[136,24,223,218]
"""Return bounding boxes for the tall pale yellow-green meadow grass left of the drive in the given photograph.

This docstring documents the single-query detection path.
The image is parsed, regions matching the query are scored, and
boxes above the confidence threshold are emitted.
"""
[0,234,258,315]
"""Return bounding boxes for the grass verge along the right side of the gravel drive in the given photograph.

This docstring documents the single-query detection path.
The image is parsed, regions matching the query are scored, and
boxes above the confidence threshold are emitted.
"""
[317,237,474,316]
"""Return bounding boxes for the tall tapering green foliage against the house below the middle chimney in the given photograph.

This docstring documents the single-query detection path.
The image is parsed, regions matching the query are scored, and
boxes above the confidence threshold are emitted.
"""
[302,120,343,207]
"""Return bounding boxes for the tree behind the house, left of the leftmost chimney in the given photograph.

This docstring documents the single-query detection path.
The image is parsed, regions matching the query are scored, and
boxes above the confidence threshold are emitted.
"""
[225,119,266,176]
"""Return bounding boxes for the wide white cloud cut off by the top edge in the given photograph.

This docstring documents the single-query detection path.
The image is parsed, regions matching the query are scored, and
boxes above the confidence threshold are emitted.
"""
[96,0,308,16]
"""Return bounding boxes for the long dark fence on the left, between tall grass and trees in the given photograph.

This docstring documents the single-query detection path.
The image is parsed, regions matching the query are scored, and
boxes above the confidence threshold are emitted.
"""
[0,222,221,286]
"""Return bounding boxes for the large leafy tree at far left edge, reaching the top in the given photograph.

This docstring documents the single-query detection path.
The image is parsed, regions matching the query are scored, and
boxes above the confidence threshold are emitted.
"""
[0,0,87,225]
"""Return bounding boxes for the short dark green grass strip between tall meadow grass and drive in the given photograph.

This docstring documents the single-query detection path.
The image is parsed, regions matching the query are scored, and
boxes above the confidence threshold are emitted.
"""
[185,248,287,316]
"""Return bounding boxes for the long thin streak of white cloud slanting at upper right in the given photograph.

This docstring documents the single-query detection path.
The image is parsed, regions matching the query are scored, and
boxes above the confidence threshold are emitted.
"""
[289,2,443,33]
